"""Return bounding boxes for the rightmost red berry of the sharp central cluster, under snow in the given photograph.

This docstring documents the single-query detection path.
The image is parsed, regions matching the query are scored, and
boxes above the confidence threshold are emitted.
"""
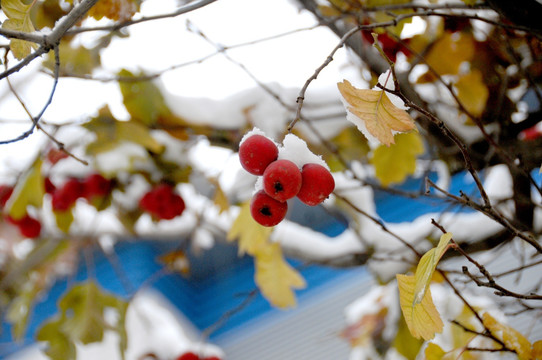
[297,164,335,206]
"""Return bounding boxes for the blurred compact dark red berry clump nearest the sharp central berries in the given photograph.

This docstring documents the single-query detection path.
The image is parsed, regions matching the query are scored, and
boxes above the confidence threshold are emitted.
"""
[139,184,185,220]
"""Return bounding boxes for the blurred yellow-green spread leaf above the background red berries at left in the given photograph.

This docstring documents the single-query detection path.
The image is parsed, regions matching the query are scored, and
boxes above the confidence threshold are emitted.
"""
[83,107,164,155]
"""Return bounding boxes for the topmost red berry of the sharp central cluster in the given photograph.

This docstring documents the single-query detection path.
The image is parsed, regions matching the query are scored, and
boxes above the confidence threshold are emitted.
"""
[239,135,279,175]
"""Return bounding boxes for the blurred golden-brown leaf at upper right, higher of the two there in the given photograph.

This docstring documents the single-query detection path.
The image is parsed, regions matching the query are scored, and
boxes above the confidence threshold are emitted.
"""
[425,32,474,75]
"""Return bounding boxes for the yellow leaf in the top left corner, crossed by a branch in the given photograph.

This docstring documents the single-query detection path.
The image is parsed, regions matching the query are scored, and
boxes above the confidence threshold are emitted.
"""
[2,0,37,59]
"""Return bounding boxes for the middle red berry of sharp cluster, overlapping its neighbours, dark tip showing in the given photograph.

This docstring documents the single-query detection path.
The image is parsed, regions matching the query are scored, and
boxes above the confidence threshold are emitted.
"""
[263,160,301,202]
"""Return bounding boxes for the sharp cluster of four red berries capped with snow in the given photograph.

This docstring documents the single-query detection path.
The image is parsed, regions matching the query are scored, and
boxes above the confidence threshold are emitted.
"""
[239,135,335,226]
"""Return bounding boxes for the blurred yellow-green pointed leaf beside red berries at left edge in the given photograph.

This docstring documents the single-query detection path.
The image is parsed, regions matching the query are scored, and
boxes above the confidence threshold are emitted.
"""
[6,158,45,220]
